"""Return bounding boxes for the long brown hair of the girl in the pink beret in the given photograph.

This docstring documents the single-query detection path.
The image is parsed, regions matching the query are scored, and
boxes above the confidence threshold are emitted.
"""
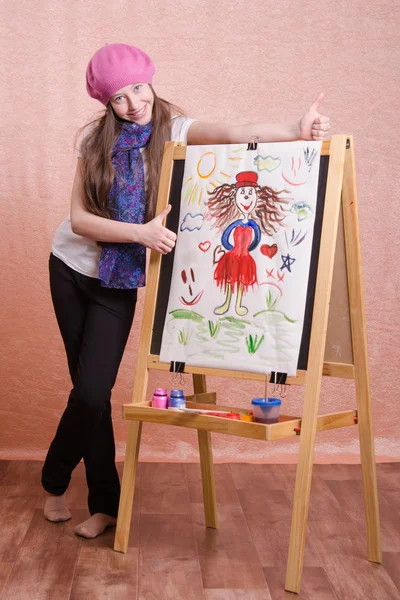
[78,86,183,221]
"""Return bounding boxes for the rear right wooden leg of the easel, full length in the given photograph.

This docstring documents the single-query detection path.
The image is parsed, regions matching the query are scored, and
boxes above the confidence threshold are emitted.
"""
[342,137,382,563]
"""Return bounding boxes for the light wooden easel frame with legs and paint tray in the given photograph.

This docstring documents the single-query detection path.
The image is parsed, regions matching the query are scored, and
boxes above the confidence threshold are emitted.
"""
[114,135,382,593]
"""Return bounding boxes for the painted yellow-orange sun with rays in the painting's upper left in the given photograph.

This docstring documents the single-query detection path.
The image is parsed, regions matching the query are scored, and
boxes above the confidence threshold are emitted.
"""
[183,146,246,206]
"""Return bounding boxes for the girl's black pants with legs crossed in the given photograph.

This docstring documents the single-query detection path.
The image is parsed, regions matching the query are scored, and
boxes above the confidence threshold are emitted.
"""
[42,254,137,517]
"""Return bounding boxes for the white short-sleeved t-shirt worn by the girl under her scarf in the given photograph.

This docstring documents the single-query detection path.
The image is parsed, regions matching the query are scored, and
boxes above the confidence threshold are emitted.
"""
[51,116,194,278]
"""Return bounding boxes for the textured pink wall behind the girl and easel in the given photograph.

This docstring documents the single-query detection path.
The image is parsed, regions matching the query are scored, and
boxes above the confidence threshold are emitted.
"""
[0,0,400,462]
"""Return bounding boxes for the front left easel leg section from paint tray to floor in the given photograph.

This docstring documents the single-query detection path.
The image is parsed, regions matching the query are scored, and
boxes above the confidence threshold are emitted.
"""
[114,421,142,552]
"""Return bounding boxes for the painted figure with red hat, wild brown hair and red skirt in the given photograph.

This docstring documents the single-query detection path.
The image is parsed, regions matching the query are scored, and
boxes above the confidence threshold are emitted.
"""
[207,171,289,317]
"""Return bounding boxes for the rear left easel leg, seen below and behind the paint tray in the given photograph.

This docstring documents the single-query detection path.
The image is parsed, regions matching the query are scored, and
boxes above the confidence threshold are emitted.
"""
[193,375,218,529]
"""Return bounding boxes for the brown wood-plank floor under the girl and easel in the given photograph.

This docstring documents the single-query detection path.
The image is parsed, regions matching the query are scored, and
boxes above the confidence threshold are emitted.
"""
[0,461,400,600]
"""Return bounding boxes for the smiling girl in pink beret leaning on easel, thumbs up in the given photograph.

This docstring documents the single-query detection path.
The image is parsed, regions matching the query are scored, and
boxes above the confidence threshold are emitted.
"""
[42,44,330,538]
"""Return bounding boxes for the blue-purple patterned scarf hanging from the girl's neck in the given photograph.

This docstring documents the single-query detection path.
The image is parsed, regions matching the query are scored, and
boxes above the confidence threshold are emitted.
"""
[99,123,152,289]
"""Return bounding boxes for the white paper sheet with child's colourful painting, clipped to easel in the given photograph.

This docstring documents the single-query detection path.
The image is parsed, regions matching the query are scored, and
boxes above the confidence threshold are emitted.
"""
[160,142,321,375]
